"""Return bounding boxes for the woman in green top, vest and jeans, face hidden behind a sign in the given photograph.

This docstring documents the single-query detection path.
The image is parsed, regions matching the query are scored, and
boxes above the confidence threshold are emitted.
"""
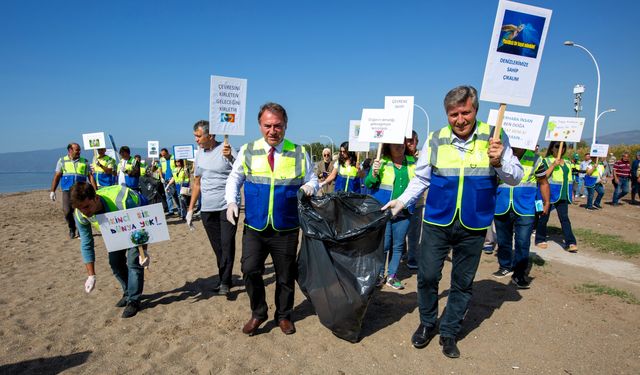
[364,143,416,289]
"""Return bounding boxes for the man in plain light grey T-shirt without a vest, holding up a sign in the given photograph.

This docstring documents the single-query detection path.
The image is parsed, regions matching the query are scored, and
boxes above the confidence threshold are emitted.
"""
[186,120,239,295]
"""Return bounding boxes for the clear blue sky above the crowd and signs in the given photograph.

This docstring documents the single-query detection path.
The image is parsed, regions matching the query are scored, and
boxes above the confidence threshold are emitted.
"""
[0,0,640,152]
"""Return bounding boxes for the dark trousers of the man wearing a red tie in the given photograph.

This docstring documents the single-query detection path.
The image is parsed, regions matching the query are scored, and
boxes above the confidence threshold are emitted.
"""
[240,226,299,320]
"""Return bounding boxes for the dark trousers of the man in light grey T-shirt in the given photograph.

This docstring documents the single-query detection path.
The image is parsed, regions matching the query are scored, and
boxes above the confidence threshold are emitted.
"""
[200,210,237,287]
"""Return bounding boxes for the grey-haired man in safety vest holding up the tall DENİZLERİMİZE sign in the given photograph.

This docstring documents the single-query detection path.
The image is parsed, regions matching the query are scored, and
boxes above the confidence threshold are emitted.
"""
[382,86,524,358]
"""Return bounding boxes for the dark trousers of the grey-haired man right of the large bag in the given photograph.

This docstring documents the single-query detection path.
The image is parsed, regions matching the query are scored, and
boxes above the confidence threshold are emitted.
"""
[418,218,487,337]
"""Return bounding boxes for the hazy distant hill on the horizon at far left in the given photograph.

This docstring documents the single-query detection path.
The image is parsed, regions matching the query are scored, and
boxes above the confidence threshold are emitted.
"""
[0,147,147,174]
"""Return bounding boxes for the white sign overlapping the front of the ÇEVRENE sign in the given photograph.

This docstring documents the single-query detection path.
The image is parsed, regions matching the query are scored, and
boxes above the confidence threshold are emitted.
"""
[358,108,407,143]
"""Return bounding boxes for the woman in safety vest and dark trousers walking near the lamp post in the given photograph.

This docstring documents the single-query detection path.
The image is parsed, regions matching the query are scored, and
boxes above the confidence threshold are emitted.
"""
[536,141,578,253]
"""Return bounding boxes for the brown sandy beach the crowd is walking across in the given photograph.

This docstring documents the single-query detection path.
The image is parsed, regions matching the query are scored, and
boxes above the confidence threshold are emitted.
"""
[0,191,640,375]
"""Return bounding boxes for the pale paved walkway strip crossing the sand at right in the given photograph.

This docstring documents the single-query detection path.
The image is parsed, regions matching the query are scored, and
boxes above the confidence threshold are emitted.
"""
[530,241,640,286]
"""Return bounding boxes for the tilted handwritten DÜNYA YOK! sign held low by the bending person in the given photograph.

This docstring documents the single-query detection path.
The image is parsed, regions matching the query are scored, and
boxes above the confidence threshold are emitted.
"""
[96,203,169,252]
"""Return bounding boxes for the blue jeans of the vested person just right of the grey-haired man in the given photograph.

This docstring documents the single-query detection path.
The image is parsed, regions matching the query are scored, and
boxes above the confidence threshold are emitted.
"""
[494,209,536,277]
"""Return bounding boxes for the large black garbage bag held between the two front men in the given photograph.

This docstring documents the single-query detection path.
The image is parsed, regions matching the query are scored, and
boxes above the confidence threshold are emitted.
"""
[298,192,389,342]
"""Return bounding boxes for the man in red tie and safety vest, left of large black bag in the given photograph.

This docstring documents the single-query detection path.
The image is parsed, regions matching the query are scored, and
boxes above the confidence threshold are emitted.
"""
[225,103,318,336]
